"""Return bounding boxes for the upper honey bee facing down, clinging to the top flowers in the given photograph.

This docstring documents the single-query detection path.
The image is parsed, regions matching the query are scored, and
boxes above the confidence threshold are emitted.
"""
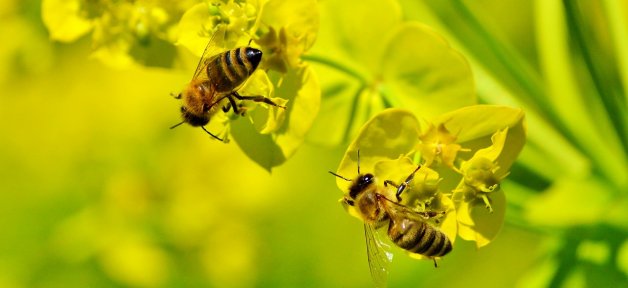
[170,26,286,141]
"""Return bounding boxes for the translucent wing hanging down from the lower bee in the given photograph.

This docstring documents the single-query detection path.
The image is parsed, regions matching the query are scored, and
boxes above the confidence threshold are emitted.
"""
[364,223,392,288]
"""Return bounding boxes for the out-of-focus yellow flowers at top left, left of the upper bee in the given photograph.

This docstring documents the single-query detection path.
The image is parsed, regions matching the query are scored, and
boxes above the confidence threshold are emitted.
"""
[42,0,190,67]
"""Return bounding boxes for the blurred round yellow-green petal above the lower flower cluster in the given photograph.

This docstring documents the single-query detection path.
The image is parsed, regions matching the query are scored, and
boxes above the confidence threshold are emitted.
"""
[381,23,477,118]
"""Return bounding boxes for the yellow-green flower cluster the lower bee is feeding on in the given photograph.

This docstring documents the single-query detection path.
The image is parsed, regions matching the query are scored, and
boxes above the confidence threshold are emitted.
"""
[337,105,526,254]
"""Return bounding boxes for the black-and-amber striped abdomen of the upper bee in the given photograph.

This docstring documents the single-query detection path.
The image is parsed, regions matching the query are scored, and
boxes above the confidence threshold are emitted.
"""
[207,47,262,93]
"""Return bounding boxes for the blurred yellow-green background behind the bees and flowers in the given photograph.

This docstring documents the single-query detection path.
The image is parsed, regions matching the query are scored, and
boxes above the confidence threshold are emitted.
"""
[0,0,628,287]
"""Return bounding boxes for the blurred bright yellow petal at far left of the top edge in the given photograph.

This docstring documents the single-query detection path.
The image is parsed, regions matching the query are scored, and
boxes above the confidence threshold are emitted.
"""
[41,0,92,42]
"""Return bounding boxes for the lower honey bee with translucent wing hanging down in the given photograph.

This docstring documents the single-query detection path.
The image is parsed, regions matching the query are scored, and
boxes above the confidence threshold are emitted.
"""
[329,151,452,287]
